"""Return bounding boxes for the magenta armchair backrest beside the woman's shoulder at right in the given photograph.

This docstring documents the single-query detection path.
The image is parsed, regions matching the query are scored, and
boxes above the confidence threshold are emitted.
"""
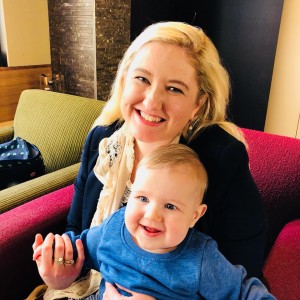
[243,129,300,252]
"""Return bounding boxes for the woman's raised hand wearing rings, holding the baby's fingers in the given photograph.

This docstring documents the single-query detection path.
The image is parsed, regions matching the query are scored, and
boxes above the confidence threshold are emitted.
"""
[32,233,84,290]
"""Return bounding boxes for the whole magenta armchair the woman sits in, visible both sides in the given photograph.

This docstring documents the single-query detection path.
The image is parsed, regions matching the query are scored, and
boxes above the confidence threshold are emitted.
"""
[0,129,300,300]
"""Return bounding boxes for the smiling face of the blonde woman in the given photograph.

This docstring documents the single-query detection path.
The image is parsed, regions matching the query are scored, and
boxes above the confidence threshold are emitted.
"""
[121,42,199,144]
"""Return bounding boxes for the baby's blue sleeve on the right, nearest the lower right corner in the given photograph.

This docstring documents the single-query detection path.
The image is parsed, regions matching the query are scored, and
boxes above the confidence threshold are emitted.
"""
[199,240,276,300]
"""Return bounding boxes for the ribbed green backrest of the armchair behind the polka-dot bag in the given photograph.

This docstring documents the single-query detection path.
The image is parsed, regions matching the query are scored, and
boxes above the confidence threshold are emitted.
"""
[14,90,104,173]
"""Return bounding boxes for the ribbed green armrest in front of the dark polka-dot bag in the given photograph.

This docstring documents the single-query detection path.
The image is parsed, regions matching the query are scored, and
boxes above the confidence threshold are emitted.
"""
[0,163,80,213]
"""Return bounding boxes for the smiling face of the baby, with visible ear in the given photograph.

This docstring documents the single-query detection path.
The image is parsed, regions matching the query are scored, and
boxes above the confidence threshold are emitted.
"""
[125,166,206,253]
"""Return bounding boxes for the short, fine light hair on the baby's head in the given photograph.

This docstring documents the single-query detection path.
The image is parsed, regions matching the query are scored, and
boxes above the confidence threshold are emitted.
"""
[138,144,208,198]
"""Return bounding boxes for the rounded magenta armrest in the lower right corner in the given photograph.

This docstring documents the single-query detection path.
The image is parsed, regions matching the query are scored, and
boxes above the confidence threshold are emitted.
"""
[263,219,300,300]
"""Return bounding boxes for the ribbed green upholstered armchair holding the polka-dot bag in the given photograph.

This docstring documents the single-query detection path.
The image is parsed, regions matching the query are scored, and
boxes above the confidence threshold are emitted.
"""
[0,90,105,213]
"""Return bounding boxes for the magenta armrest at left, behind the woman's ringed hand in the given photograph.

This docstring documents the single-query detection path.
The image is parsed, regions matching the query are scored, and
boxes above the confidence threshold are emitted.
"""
[0,185,73,299]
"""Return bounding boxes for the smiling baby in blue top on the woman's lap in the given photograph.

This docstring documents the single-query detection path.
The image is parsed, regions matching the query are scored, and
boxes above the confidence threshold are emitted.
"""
[34,144,275,300]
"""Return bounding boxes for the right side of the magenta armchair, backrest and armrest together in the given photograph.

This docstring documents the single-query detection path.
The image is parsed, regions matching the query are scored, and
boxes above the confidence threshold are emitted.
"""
[243,129,300,300]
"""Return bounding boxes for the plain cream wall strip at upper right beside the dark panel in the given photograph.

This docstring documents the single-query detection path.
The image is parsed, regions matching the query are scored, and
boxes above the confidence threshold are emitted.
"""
[265,0,300,138]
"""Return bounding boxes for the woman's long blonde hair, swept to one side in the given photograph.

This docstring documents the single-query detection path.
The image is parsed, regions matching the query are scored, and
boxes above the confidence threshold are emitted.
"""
[95,22,245,142]
